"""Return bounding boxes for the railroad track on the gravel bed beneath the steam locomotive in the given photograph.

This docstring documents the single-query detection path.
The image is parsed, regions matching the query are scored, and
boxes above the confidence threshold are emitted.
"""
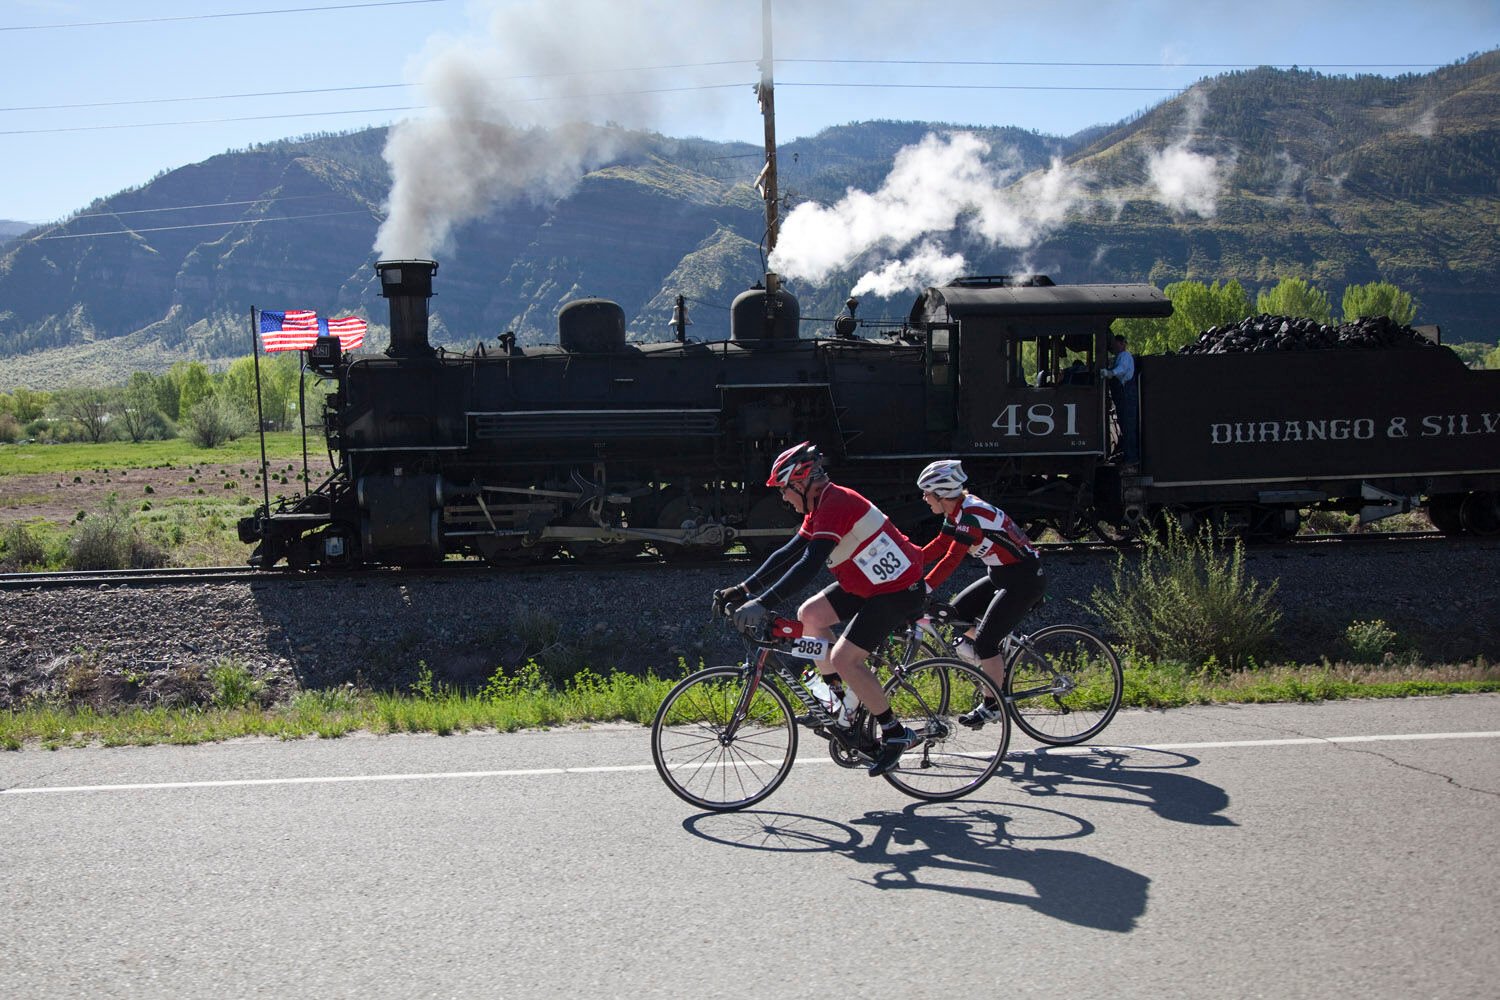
[0,531,1464,591]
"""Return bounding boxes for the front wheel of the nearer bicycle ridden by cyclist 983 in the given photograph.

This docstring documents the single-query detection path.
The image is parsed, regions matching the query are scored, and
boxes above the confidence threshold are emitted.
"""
[651,667,797,811]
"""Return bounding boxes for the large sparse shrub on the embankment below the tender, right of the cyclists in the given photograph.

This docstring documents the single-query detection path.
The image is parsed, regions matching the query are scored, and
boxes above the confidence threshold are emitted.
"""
[1088,519,1281,673]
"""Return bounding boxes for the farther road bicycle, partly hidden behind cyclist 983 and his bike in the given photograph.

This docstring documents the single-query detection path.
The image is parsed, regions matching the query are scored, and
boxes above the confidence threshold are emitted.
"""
[872,601,1125,747]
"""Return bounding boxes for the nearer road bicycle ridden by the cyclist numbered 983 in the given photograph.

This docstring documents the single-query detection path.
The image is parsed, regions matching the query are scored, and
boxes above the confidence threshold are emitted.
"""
[651,618,1011,811]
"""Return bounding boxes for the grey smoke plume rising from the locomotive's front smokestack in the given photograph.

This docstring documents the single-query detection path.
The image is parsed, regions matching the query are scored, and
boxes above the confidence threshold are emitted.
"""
[375,0,741,259]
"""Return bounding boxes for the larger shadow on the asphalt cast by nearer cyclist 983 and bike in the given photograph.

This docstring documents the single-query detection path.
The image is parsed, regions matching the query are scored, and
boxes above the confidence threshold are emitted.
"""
[683,799,1151,933]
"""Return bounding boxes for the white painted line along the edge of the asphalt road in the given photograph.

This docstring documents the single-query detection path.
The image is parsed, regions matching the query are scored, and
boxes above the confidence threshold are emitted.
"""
[0,730,1500,796]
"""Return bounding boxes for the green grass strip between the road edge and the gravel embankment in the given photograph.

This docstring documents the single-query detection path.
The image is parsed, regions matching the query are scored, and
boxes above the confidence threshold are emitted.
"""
[0,660,1500,750]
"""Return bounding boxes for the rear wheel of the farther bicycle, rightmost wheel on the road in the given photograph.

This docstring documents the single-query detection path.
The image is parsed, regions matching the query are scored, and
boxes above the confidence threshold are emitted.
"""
[1005,625,1125,747]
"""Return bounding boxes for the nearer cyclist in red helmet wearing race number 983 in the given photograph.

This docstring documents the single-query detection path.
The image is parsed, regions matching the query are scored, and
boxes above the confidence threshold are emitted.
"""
[714,441,927,775]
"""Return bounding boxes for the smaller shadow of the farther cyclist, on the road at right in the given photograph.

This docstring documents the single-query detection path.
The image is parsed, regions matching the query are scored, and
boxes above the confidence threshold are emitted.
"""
[992,747,1238,826]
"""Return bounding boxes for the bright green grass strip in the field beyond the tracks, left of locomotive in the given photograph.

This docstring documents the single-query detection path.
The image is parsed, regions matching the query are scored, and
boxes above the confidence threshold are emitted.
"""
[0,430,327,475]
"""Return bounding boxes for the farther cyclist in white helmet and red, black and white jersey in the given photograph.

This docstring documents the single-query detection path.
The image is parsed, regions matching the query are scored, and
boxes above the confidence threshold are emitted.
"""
[917,459,1047,729]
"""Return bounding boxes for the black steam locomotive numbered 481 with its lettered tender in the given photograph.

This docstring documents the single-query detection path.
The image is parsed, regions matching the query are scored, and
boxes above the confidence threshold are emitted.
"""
[240,261,1500,568]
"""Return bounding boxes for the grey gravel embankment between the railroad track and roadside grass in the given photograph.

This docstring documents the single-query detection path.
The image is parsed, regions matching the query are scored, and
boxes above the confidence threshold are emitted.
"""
[0,540,1500,708]
